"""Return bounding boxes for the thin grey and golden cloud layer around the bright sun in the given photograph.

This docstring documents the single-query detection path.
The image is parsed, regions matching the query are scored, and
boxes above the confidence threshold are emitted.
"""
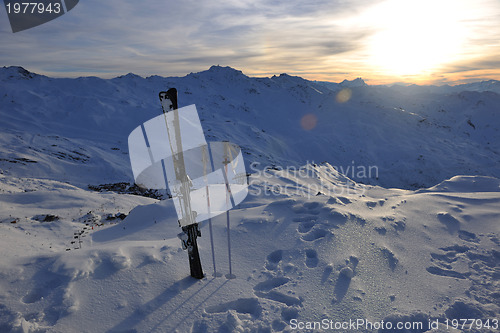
[0,0,500,79]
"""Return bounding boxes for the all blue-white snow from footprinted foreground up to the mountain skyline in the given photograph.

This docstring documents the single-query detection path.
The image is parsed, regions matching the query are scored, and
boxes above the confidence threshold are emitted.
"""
[0,66,500,332]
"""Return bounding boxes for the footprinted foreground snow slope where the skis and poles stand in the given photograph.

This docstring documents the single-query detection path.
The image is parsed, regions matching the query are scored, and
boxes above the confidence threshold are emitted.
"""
[0,165,500,332]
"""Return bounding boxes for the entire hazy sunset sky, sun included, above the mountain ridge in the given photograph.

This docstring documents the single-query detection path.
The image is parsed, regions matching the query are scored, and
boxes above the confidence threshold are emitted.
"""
[0,0,500,84]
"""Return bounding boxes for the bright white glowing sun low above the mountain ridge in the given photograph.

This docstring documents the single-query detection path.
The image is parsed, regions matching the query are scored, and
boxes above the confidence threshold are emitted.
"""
[368,0,467,76]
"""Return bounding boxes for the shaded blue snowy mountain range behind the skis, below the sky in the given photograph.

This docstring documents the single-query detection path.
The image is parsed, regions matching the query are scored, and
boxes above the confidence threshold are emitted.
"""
[0,66,500,188]
